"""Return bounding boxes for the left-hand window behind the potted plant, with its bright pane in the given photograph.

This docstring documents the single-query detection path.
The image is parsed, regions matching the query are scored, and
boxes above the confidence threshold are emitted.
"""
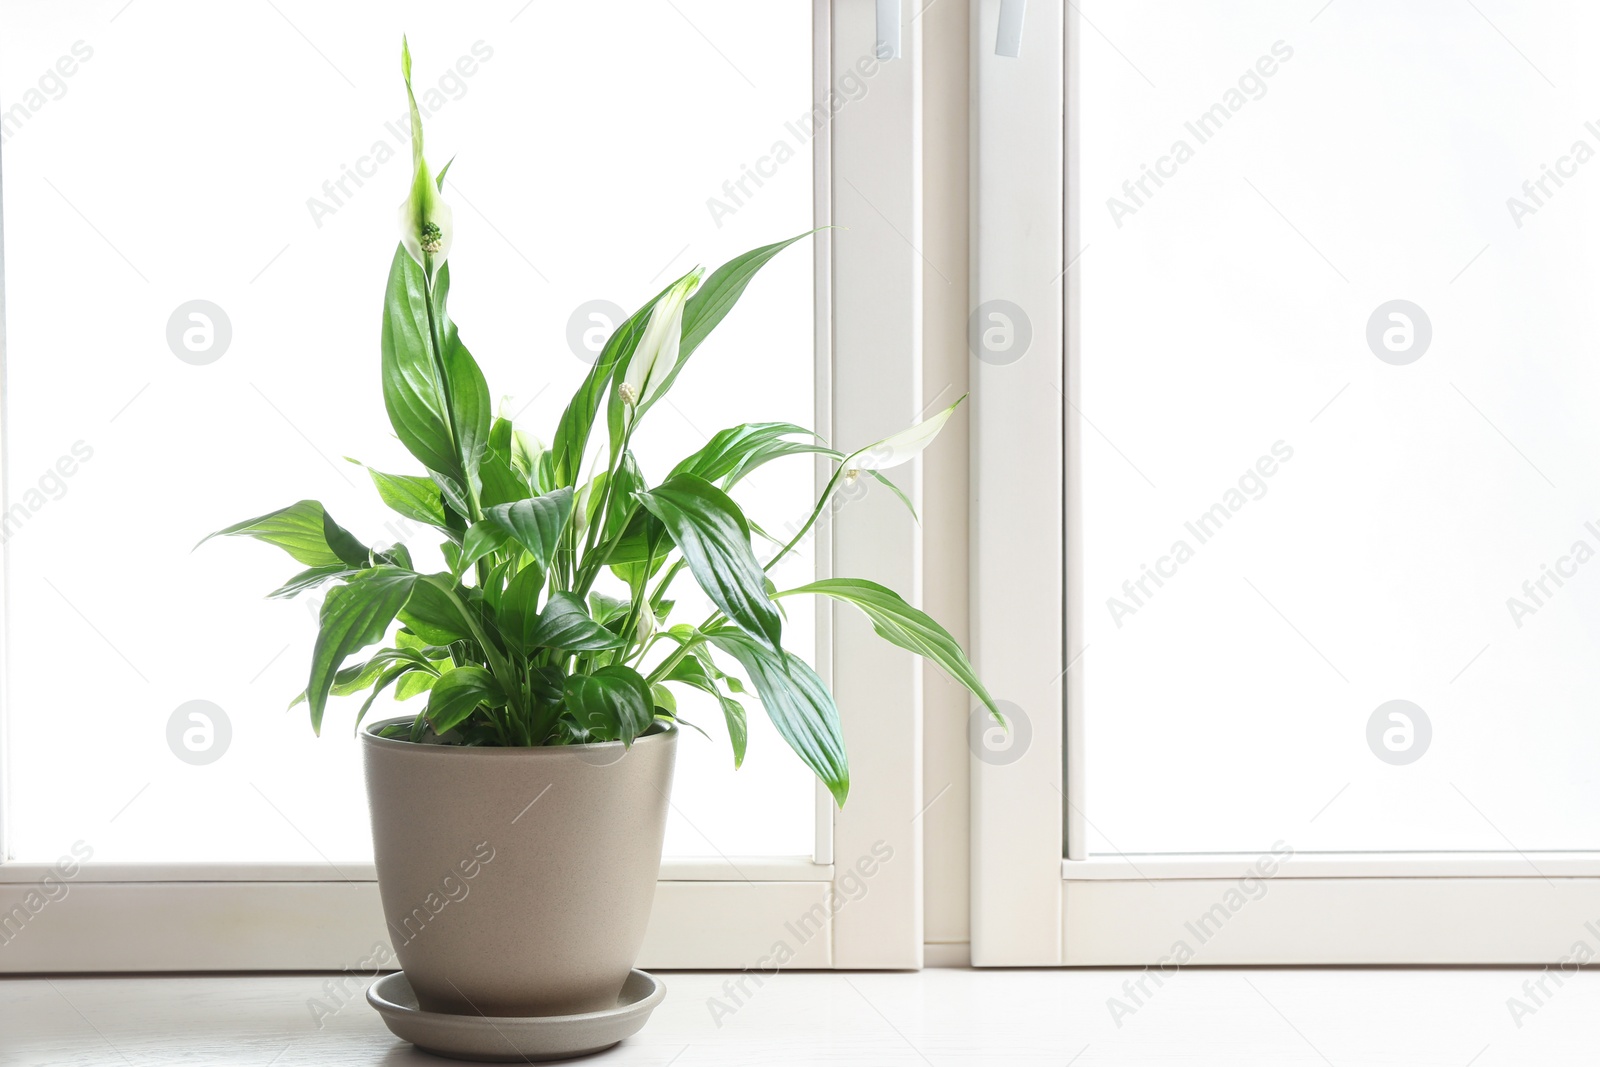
[0,0,920,969]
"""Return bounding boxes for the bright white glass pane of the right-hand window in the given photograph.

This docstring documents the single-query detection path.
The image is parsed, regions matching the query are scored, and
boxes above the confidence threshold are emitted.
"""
[1069,0,1600,853]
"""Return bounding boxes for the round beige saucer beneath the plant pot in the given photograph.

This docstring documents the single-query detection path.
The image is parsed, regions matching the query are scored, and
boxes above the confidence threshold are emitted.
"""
[366,969,667,1064]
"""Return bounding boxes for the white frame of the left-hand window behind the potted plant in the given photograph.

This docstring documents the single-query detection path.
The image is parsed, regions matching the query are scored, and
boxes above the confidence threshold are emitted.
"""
[0,0,923,974]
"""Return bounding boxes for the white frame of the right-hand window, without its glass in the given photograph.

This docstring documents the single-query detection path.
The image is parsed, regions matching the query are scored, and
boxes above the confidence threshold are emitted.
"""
[971,0,1600,966]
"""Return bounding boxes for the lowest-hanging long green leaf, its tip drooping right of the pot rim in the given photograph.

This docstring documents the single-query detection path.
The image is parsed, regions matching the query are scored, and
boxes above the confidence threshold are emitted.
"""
[707,627,850,806]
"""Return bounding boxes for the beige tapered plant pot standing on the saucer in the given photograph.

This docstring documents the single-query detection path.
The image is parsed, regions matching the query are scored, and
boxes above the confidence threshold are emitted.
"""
[362,718,678,1016]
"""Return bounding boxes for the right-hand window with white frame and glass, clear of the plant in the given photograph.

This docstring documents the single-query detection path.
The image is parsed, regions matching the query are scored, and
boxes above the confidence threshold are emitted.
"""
[974,3,1600,963]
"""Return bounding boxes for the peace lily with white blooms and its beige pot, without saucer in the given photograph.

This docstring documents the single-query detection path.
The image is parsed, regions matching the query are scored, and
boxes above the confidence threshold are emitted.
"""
[211,37,998,1049]
